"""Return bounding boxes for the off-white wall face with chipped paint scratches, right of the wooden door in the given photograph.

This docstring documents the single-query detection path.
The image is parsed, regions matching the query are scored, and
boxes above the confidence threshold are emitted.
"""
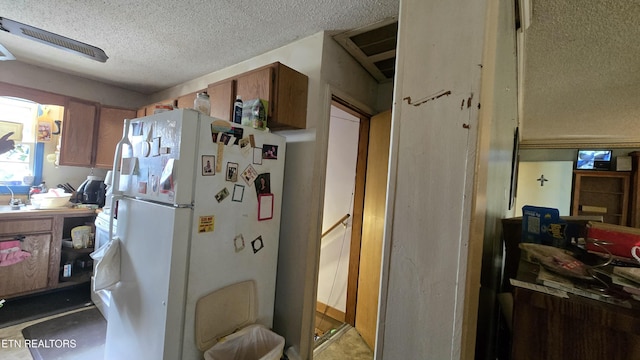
[376,0,487,359]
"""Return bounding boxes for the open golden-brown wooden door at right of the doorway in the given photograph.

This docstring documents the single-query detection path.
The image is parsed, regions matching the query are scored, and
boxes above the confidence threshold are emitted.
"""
[356,111,391,349]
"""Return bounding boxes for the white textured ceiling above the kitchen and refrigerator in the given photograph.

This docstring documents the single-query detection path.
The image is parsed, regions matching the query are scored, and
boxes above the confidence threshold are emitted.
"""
[0,0,399,94]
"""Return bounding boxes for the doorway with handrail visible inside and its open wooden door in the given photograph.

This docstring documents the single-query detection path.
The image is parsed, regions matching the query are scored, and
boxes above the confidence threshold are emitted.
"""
[315,98,391,349]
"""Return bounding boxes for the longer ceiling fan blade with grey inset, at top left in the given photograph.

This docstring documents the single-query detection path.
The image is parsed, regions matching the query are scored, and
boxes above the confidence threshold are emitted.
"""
[0,17,109,62]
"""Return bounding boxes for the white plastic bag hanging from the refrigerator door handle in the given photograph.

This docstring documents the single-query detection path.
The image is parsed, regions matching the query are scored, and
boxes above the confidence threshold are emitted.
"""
[89,237,120,291]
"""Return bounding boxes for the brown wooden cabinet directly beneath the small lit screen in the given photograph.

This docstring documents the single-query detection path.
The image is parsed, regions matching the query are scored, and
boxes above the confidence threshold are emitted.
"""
[571,170,630,226]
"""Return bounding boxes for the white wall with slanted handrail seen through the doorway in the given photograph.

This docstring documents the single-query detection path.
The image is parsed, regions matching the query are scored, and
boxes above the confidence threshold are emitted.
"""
[317,106,360,312]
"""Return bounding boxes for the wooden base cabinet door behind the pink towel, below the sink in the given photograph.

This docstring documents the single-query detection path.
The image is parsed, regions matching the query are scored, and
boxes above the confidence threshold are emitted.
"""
[0,233,53,298]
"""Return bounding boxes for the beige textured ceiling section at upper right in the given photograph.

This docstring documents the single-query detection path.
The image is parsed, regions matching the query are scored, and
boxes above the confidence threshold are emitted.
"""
[521,0,640,140]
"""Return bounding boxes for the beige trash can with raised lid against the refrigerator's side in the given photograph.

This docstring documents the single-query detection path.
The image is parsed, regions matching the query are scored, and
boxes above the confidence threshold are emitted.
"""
[195,280,285,360]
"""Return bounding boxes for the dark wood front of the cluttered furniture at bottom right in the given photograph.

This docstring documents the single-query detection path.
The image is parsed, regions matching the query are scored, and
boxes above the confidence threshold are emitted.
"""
[511,288,640,360]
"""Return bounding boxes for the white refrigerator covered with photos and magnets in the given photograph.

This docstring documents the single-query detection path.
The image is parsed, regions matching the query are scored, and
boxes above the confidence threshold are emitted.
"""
[105,109,285,360]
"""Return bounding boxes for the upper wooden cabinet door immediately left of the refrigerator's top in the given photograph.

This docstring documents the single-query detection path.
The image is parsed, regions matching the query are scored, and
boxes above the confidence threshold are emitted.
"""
[95,106,136,169]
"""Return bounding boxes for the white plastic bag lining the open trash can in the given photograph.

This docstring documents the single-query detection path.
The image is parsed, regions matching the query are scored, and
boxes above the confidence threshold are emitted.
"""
[204,325,284,360]
